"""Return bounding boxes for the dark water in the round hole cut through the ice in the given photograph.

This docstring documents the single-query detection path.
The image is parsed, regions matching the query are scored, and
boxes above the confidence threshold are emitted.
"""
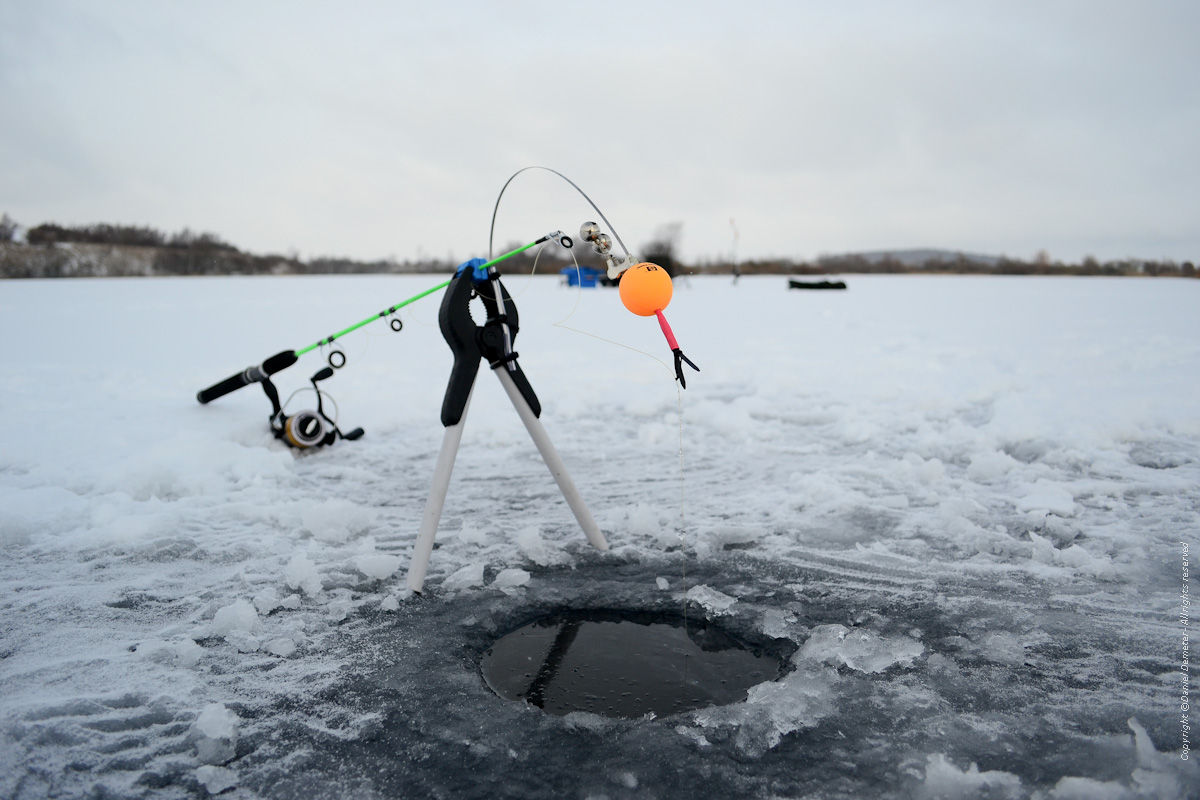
[482,610,780,718]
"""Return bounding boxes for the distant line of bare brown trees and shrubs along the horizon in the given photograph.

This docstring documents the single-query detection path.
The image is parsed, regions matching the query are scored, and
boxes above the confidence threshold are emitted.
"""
[0,213,1196,278]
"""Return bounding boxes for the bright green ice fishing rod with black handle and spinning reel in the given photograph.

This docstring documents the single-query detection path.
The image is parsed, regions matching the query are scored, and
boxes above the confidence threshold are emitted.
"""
[196,230,572,449]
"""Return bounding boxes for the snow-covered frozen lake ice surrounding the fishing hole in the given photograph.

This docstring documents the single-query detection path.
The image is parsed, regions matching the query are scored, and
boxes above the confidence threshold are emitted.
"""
[0,276,1200,800]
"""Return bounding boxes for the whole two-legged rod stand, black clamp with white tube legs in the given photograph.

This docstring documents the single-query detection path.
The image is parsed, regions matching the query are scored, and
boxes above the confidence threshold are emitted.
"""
[408,260,608,593]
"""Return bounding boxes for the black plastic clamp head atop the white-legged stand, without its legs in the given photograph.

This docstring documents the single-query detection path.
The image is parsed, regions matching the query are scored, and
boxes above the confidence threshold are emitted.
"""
[438,259,541,428]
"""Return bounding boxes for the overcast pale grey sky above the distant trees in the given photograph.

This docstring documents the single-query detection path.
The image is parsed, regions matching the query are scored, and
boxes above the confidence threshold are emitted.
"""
[0,0,1200,260]
